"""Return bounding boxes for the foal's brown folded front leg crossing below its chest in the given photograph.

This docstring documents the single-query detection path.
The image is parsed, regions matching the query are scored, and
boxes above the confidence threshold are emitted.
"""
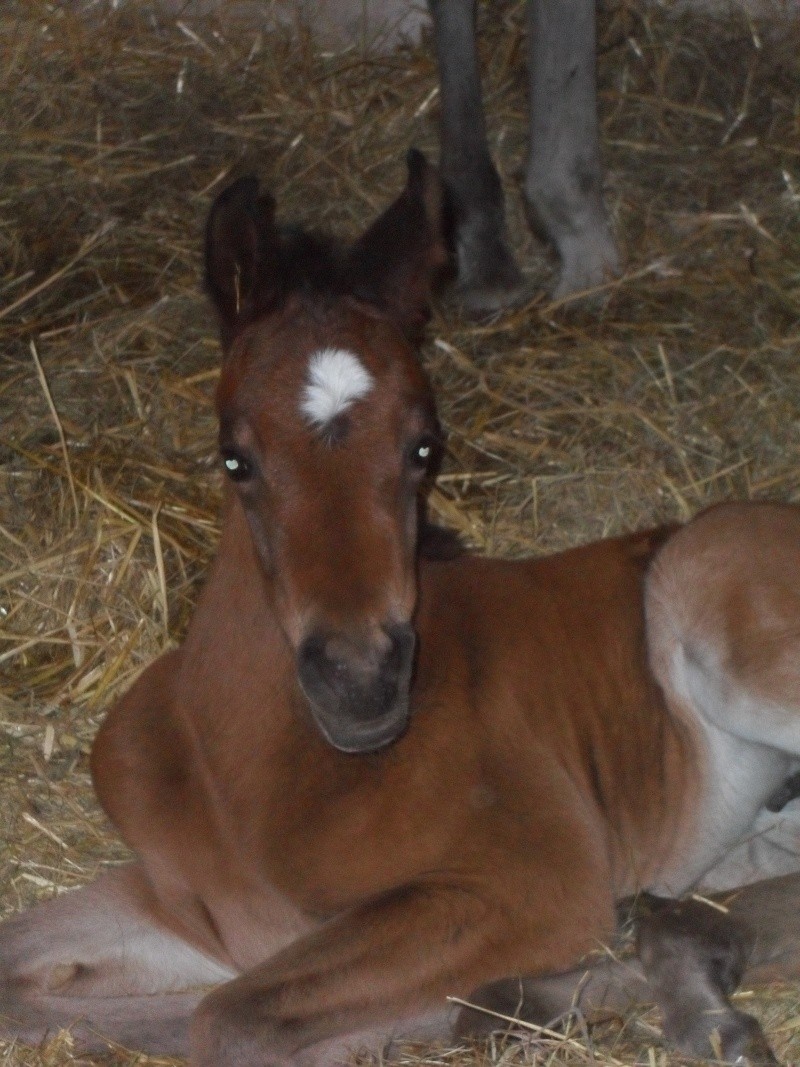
[191,885,605,1067]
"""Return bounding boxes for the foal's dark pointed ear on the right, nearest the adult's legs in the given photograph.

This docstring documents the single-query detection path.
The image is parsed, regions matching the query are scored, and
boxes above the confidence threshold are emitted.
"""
[345,148,448,341]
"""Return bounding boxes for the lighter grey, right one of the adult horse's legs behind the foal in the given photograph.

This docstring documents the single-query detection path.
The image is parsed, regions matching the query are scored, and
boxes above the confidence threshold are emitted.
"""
[525,0,620,299]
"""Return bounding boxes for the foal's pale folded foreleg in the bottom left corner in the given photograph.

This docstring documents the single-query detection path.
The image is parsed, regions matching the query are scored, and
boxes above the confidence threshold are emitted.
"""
[0,863,235,1055]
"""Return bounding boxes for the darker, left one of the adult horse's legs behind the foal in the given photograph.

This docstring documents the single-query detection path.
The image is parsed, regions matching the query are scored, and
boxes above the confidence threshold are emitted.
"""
[429,0,525,314]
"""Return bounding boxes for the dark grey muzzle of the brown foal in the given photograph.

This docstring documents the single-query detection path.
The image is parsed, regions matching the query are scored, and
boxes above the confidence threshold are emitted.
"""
[298,624,416,752]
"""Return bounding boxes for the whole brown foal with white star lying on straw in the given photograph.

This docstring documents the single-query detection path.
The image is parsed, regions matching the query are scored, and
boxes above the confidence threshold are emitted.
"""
[0,154,800,1067]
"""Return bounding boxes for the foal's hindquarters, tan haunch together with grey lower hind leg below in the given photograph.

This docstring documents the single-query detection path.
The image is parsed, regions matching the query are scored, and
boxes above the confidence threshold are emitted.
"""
[458,504,800,1064]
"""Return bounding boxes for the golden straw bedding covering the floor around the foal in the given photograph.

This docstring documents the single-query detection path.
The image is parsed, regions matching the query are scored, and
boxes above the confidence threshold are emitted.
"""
[0,0,800,1065]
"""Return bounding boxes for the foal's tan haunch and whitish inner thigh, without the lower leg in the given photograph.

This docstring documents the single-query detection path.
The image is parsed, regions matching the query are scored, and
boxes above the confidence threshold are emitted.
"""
[645,504,800,890]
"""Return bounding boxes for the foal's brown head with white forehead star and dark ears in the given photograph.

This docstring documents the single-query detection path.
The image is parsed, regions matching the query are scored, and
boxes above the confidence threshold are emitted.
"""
[206,153,445,752]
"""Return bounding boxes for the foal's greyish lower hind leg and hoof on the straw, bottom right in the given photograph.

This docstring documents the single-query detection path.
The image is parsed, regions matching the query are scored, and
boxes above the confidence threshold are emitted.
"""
[455,896,780,1065]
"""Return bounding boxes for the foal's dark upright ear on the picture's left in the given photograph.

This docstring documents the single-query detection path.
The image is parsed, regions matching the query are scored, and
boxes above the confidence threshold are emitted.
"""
[206,175,279,347]
